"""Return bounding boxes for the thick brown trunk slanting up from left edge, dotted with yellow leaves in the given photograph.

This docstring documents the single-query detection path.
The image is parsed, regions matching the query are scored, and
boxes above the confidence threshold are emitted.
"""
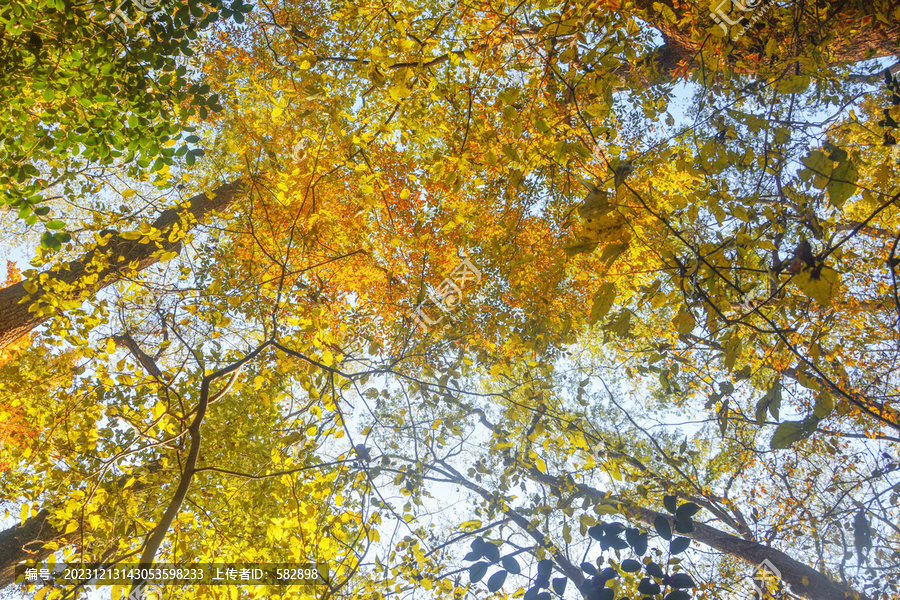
[0,180,244,349]
